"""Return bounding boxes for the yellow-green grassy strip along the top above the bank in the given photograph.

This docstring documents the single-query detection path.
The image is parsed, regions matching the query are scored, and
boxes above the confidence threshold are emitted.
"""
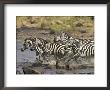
[16,16,94,32]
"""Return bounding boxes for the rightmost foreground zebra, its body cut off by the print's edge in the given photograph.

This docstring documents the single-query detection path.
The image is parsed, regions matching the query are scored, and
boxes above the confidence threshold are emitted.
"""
[65,42,94,69]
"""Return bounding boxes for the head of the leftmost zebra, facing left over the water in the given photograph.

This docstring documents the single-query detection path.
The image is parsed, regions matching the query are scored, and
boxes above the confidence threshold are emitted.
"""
[21,37,35,51]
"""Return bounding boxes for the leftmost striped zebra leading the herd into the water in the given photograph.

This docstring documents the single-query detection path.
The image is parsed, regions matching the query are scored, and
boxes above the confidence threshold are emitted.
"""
[21,37,47,61]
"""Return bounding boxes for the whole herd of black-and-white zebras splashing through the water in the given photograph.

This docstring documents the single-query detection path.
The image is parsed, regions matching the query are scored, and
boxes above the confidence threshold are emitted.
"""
[21,32,94,68]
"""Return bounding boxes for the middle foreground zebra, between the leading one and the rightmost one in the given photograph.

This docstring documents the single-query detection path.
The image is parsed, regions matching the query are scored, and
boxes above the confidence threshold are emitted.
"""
[40,43,72,68]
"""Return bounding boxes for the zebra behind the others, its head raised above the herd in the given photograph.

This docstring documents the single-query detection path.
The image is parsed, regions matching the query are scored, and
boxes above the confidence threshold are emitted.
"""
[54,32,94,52]
